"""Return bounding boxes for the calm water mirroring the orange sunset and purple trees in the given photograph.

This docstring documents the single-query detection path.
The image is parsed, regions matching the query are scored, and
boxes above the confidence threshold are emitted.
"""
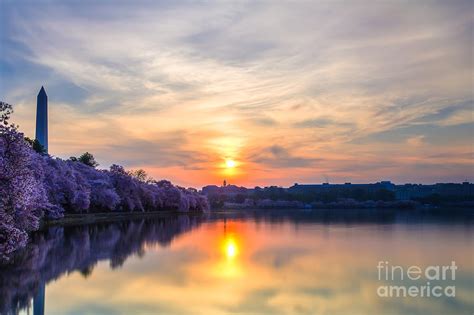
[0,210,474,315]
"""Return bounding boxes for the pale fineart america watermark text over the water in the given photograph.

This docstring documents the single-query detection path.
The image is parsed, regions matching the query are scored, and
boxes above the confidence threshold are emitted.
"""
[377,261,458,297]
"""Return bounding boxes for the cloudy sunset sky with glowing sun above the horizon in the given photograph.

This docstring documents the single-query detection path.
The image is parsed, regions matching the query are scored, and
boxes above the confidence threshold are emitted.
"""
[0,0,474,188]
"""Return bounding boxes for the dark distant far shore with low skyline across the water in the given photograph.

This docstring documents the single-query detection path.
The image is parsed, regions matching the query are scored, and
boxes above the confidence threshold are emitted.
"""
[202,181,474,208]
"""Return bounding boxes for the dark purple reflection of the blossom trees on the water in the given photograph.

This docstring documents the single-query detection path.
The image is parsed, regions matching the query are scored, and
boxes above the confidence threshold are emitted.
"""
[0,215,203,315]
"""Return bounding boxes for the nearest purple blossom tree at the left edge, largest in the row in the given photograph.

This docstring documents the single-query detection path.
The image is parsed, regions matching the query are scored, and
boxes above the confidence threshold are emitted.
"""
[0,102,47,257]
